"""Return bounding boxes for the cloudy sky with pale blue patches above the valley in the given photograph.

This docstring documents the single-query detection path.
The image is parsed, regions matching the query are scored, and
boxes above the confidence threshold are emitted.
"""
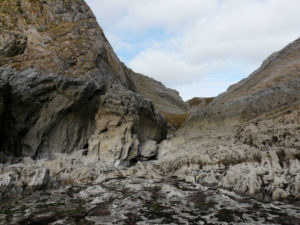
[86,0,300,100]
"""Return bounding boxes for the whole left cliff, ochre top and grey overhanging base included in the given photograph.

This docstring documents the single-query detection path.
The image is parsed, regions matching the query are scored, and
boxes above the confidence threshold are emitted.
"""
[0,0,171,165]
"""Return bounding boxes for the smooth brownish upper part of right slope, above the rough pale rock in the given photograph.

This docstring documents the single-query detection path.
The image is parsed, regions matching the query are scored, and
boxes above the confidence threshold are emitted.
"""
[187,39,300,129]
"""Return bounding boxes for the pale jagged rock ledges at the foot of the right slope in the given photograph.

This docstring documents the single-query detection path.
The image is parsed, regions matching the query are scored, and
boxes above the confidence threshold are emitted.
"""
[157,119,300,201]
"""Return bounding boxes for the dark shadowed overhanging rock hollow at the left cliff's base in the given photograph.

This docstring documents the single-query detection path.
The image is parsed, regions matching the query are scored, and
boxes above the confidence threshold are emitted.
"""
[0,69,104,158]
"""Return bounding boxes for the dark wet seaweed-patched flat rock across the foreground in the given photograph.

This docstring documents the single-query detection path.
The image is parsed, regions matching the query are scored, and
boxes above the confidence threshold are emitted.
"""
[0,178,300,225]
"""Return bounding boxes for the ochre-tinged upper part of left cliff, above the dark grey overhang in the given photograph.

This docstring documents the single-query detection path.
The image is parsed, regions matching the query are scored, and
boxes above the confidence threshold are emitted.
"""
[0,0,187,120]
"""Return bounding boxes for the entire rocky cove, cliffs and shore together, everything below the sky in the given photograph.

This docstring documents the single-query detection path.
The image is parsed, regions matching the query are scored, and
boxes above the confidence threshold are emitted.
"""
[0,0,300,225]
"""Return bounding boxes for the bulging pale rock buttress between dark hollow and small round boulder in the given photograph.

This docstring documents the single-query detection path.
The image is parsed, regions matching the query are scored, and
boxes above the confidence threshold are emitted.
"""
[89,85,167,165]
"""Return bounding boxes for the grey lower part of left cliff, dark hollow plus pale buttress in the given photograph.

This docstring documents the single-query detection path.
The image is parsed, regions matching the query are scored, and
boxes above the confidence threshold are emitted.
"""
[0,69,166,163]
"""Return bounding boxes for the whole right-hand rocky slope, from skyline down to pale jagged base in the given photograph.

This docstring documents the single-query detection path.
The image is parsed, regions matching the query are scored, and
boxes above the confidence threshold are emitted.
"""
[158,39,300,200]
